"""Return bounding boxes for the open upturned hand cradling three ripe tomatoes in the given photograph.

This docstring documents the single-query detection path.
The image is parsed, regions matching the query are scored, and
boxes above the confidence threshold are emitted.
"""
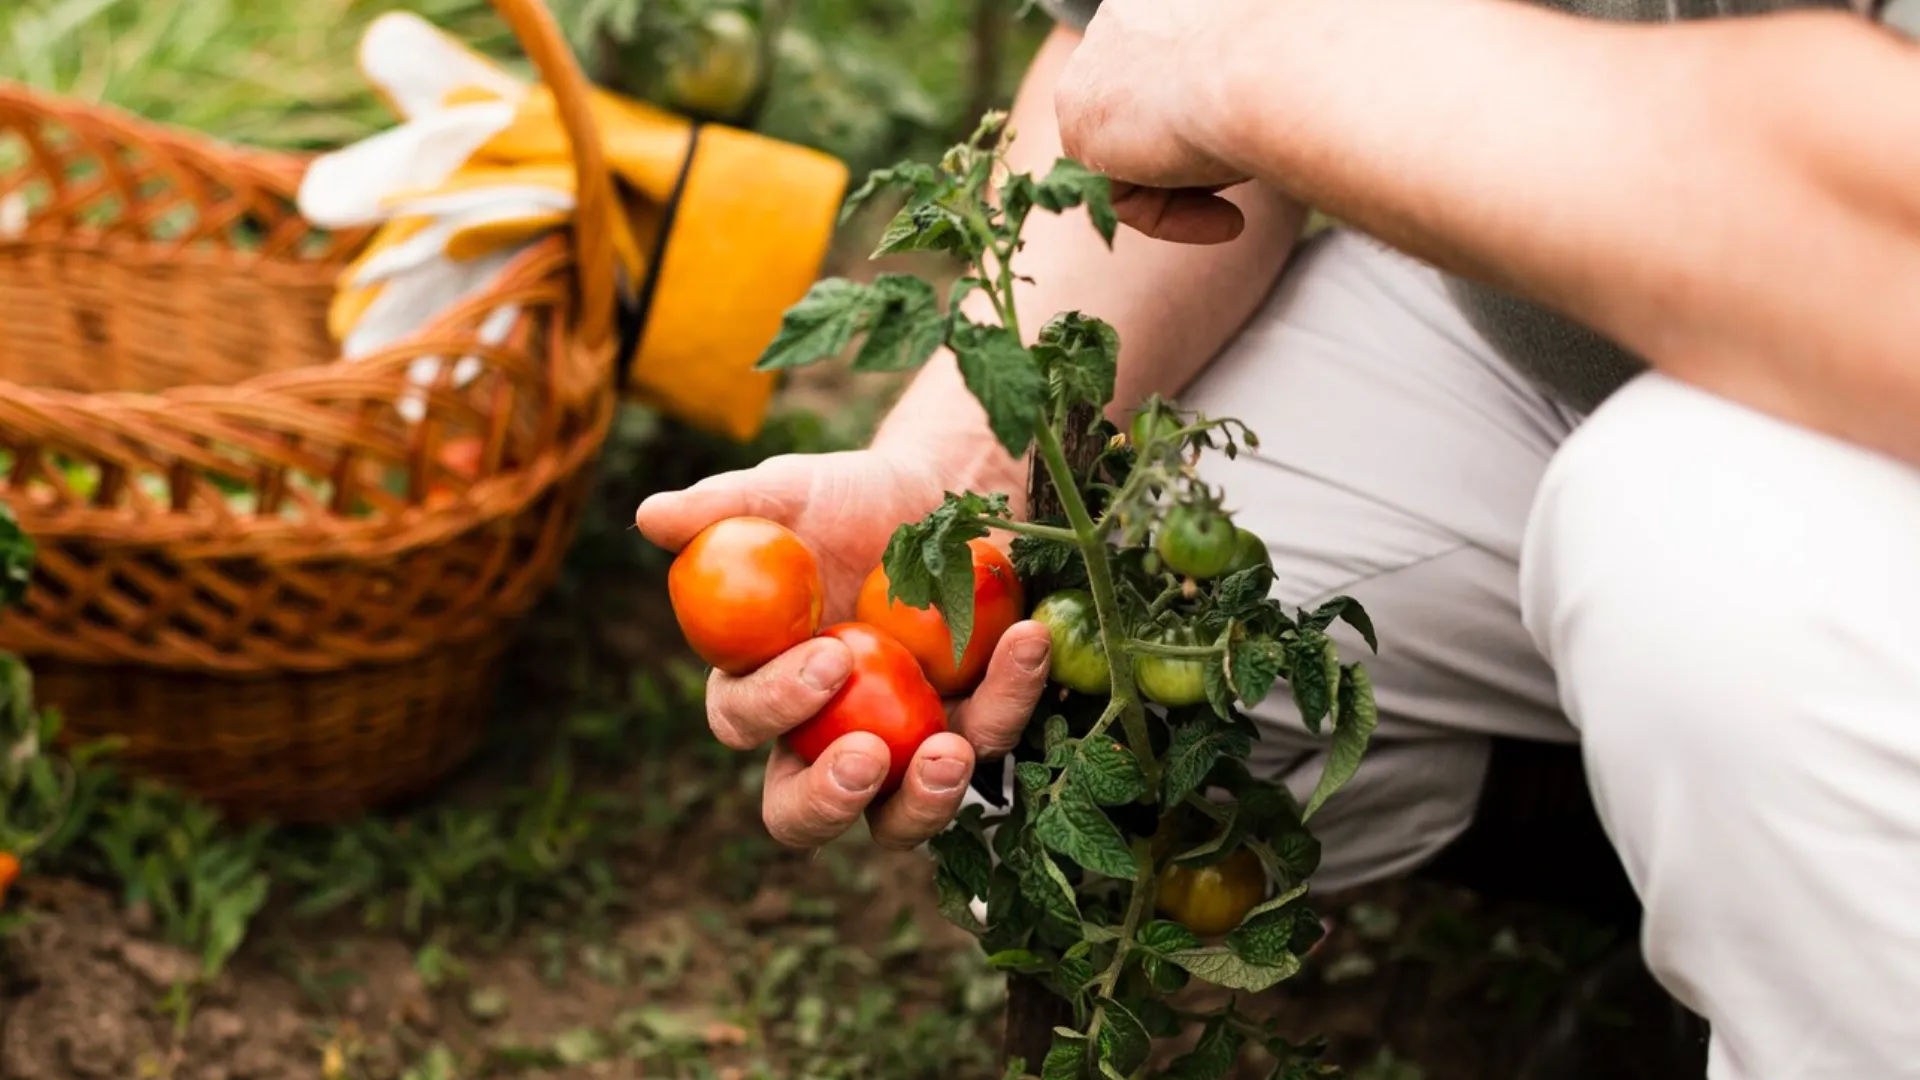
[636,452,1050,847]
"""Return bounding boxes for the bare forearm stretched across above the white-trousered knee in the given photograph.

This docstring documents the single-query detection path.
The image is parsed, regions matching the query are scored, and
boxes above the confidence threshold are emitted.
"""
[1196,0,1920,461]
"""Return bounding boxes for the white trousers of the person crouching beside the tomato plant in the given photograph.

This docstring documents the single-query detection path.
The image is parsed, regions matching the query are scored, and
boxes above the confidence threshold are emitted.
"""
[1183,233,1920,1080]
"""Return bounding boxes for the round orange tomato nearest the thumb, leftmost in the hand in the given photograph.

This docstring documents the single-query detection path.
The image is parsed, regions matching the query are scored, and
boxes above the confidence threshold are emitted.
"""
[666,517,826,675]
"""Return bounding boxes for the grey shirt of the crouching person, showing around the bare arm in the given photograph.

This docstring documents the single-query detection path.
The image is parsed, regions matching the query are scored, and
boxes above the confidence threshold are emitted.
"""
[1041,0,1866,413]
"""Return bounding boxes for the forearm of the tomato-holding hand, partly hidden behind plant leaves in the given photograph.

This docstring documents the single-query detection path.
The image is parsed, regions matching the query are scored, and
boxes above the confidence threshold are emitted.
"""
[874,31,1304,494]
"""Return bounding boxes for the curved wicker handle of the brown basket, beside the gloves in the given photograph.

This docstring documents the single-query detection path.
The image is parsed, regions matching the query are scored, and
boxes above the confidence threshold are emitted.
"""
[493,0,616,352]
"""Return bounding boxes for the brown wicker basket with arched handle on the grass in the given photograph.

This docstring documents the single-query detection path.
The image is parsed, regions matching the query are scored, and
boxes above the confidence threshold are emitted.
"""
[0,0,629,821]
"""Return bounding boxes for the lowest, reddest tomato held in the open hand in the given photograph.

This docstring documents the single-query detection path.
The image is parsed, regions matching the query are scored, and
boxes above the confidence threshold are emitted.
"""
[785,623,947,796]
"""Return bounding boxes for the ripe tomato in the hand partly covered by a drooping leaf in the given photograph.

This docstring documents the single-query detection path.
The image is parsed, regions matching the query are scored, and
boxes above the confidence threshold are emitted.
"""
[852,538,1027,698]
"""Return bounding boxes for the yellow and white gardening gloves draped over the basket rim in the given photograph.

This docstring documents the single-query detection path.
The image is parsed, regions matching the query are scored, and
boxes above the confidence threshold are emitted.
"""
[300,13,847,440]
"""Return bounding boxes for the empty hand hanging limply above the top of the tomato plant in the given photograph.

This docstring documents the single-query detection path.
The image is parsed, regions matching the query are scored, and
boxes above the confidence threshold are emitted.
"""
[1054,0,1248,244]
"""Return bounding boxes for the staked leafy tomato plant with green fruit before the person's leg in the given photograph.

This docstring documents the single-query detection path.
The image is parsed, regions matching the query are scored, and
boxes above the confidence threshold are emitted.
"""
[760,115,1377,1080]
